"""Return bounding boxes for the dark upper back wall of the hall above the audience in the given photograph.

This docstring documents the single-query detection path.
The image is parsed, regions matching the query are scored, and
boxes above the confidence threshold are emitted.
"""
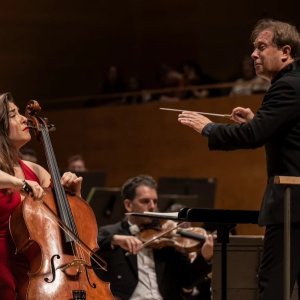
[0,0,300,103]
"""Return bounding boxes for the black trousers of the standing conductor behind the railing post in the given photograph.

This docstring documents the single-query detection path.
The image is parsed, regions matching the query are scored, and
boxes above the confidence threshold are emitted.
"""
[258,223,300,300]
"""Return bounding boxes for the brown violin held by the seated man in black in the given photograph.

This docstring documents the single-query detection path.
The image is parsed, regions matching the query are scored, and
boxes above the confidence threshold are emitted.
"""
[137,220,207,254]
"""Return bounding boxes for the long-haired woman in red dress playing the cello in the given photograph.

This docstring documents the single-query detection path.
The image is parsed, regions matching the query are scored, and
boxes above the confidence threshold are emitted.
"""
[0,93,82,300]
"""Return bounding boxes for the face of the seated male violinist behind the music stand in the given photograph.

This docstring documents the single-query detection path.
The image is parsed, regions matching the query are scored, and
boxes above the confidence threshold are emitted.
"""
[124,185,157,224]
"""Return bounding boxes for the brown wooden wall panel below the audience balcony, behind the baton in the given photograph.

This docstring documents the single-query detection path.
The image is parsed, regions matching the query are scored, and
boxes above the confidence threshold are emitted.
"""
[32,95,266,233]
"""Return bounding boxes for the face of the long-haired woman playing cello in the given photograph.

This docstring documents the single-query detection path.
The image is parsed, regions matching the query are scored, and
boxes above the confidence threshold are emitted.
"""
[8,102,31,149]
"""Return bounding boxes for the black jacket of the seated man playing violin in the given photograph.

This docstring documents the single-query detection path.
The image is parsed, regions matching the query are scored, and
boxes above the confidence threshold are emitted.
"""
[95,221,211,300]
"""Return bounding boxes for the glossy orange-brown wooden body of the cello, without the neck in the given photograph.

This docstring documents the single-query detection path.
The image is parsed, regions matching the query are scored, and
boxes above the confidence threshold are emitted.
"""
[10,189,114,300]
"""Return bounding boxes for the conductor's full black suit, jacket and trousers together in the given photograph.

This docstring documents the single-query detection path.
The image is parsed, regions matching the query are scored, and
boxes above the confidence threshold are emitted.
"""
[208,61,300,300]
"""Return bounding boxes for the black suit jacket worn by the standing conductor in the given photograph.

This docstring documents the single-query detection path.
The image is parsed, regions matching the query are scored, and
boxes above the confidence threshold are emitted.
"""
[208,62,300,225]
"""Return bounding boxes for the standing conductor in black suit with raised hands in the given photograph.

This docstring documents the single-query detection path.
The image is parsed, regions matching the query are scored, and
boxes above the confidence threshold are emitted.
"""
[178,19,300,300]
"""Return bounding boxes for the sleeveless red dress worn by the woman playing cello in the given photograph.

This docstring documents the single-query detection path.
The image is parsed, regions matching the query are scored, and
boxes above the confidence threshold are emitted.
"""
[0,161,39,300]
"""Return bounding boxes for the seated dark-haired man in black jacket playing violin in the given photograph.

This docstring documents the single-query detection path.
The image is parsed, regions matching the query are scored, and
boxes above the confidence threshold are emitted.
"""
[95,175,213,300]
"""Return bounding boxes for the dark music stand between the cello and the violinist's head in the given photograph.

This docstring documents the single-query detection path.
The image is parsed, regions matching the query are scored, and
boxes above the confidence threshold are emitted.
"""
[87,187,125,227]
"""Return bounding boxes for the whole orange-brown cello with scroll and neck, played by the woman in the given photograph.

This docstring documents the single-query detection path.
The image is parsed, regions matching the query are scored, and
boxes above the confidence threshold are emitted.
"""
[10,100,114,300]
